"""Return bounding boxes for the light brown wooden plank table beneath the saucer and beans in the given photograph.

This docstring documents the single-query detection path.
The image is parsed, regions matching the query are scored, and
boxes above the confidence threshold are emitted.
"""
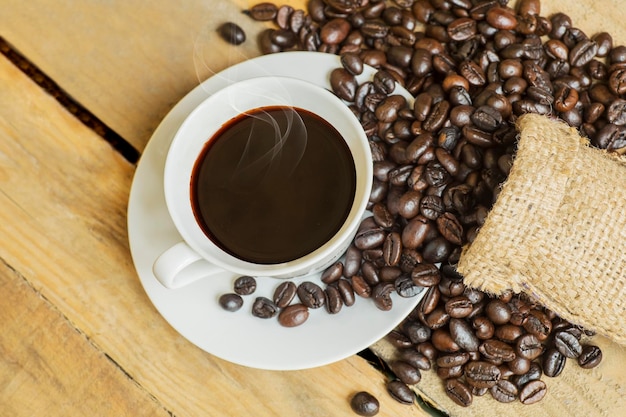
[0,0,626,416]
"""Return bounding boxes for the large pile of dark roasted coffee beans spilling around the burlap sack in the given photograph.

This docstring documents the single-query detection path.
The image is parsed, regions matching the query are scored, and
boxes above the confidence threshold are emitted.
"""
[222,0,626,406]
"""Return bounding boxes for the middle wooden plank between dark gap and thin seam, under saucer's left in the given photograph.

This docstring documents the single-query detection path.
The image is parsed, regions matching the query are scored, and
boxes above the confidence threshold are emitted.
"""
[0,58,424,417]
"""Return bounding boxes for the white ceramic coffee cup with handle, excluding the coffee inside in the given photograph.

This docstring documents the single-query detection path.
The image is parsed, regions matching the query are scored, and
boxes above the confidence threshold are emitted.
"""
[153,76,373,289]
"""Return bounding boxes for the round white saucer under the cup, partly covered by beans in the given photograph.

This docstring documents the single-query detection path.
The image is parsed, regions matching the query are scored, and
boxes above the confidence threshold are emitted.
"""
[128,52,424,370]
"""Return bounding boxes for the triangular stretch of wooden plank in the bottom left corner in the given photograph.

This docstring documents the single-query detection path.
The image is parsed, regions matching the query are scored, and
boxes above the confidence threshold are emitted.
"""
[0,262,170,417]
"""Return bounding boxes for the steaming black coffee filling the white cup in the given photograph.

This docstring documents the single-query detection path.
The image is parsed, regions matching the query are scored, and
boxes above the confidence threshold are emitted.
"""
[191,106,356,264]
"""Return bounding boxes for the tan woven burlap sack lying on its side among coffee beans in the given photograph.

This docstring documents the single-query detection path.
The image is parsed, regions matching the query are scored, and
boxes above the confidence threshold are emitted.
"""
[458,114,626,344]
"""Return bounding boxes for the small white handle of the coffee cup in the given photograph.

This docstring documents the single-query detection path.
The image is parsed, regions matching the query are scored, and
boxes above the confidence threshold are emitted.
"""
[152,242,224,289]
